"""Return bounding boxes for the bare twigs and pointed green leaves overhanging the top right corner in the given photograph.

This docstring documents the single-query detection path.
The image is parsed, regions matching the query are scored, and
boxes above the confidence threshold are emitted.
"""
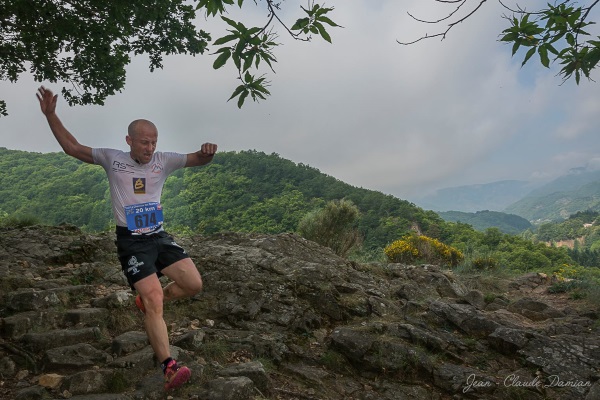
[398,0,600,84]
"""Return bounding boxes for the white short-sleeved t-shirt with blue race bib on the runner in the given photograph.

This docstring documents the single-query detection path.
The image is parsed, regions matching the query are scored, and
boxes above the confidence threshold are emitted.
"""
[92,148,187,233]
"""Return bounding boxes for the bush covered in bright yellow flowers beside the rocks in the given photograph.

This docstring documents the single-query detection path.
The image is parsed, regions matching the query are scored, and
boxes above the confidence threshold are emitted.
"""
[384,234,464,267]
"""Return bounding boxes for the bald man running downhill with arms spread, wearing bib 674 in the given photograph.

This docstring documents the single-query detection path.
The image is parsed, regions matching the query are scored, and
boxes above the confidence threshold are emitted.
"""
[36,86,217,390]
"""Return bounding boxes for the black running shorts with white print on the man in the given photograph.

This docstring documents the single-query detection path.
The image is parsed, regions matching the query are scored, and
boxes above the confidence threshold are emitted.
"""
[115,231,189,289]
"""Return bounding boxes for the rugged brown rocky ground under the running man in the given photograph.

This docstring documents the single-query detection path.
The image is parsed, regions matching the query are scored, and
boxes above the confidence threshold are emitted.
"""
[0,226,600,400]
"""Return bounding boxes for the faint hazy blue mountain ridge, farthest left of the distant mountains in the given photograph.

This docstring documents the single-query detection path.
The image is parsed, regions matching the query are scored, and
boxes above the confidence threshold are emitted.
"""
[415,180,538,212]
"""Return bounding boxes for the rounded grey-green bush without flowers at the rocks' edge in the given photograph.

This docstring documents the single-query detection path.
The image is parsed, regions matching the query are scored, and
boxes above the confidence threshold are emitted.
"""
[298,200,360,257]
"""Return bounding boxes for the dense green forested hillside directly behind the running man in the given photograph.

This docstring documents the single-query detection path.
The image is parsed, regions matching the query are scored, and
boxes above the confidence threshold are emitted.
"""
[0,148,444,248]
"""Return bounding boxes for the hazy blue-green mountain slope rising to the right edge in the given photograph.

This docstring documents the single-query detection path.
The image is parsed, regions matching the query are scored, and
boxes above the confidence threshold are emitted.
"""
[504,168,600,224]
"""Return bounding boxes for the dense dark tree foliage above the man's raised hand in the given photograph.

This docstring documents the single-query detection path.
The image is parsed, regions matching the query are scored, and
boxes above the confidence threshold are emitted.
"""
[0,0,210,115]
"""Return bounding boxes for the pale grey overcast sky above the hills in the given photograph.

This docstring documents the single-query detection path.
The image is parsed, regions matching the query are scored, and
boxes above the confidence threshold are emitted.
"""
[0,0,600,201]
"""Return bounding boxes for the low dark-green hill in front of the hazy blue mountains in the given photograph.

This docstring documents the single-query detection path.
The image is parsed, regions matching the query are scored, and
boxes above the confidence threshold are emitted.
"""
[438,210,532,235]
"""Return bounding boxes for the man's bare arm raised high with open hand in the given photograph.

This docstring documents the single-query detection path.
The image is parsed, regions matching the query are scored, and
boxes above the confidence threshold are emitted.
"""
[36,86,94,164]
